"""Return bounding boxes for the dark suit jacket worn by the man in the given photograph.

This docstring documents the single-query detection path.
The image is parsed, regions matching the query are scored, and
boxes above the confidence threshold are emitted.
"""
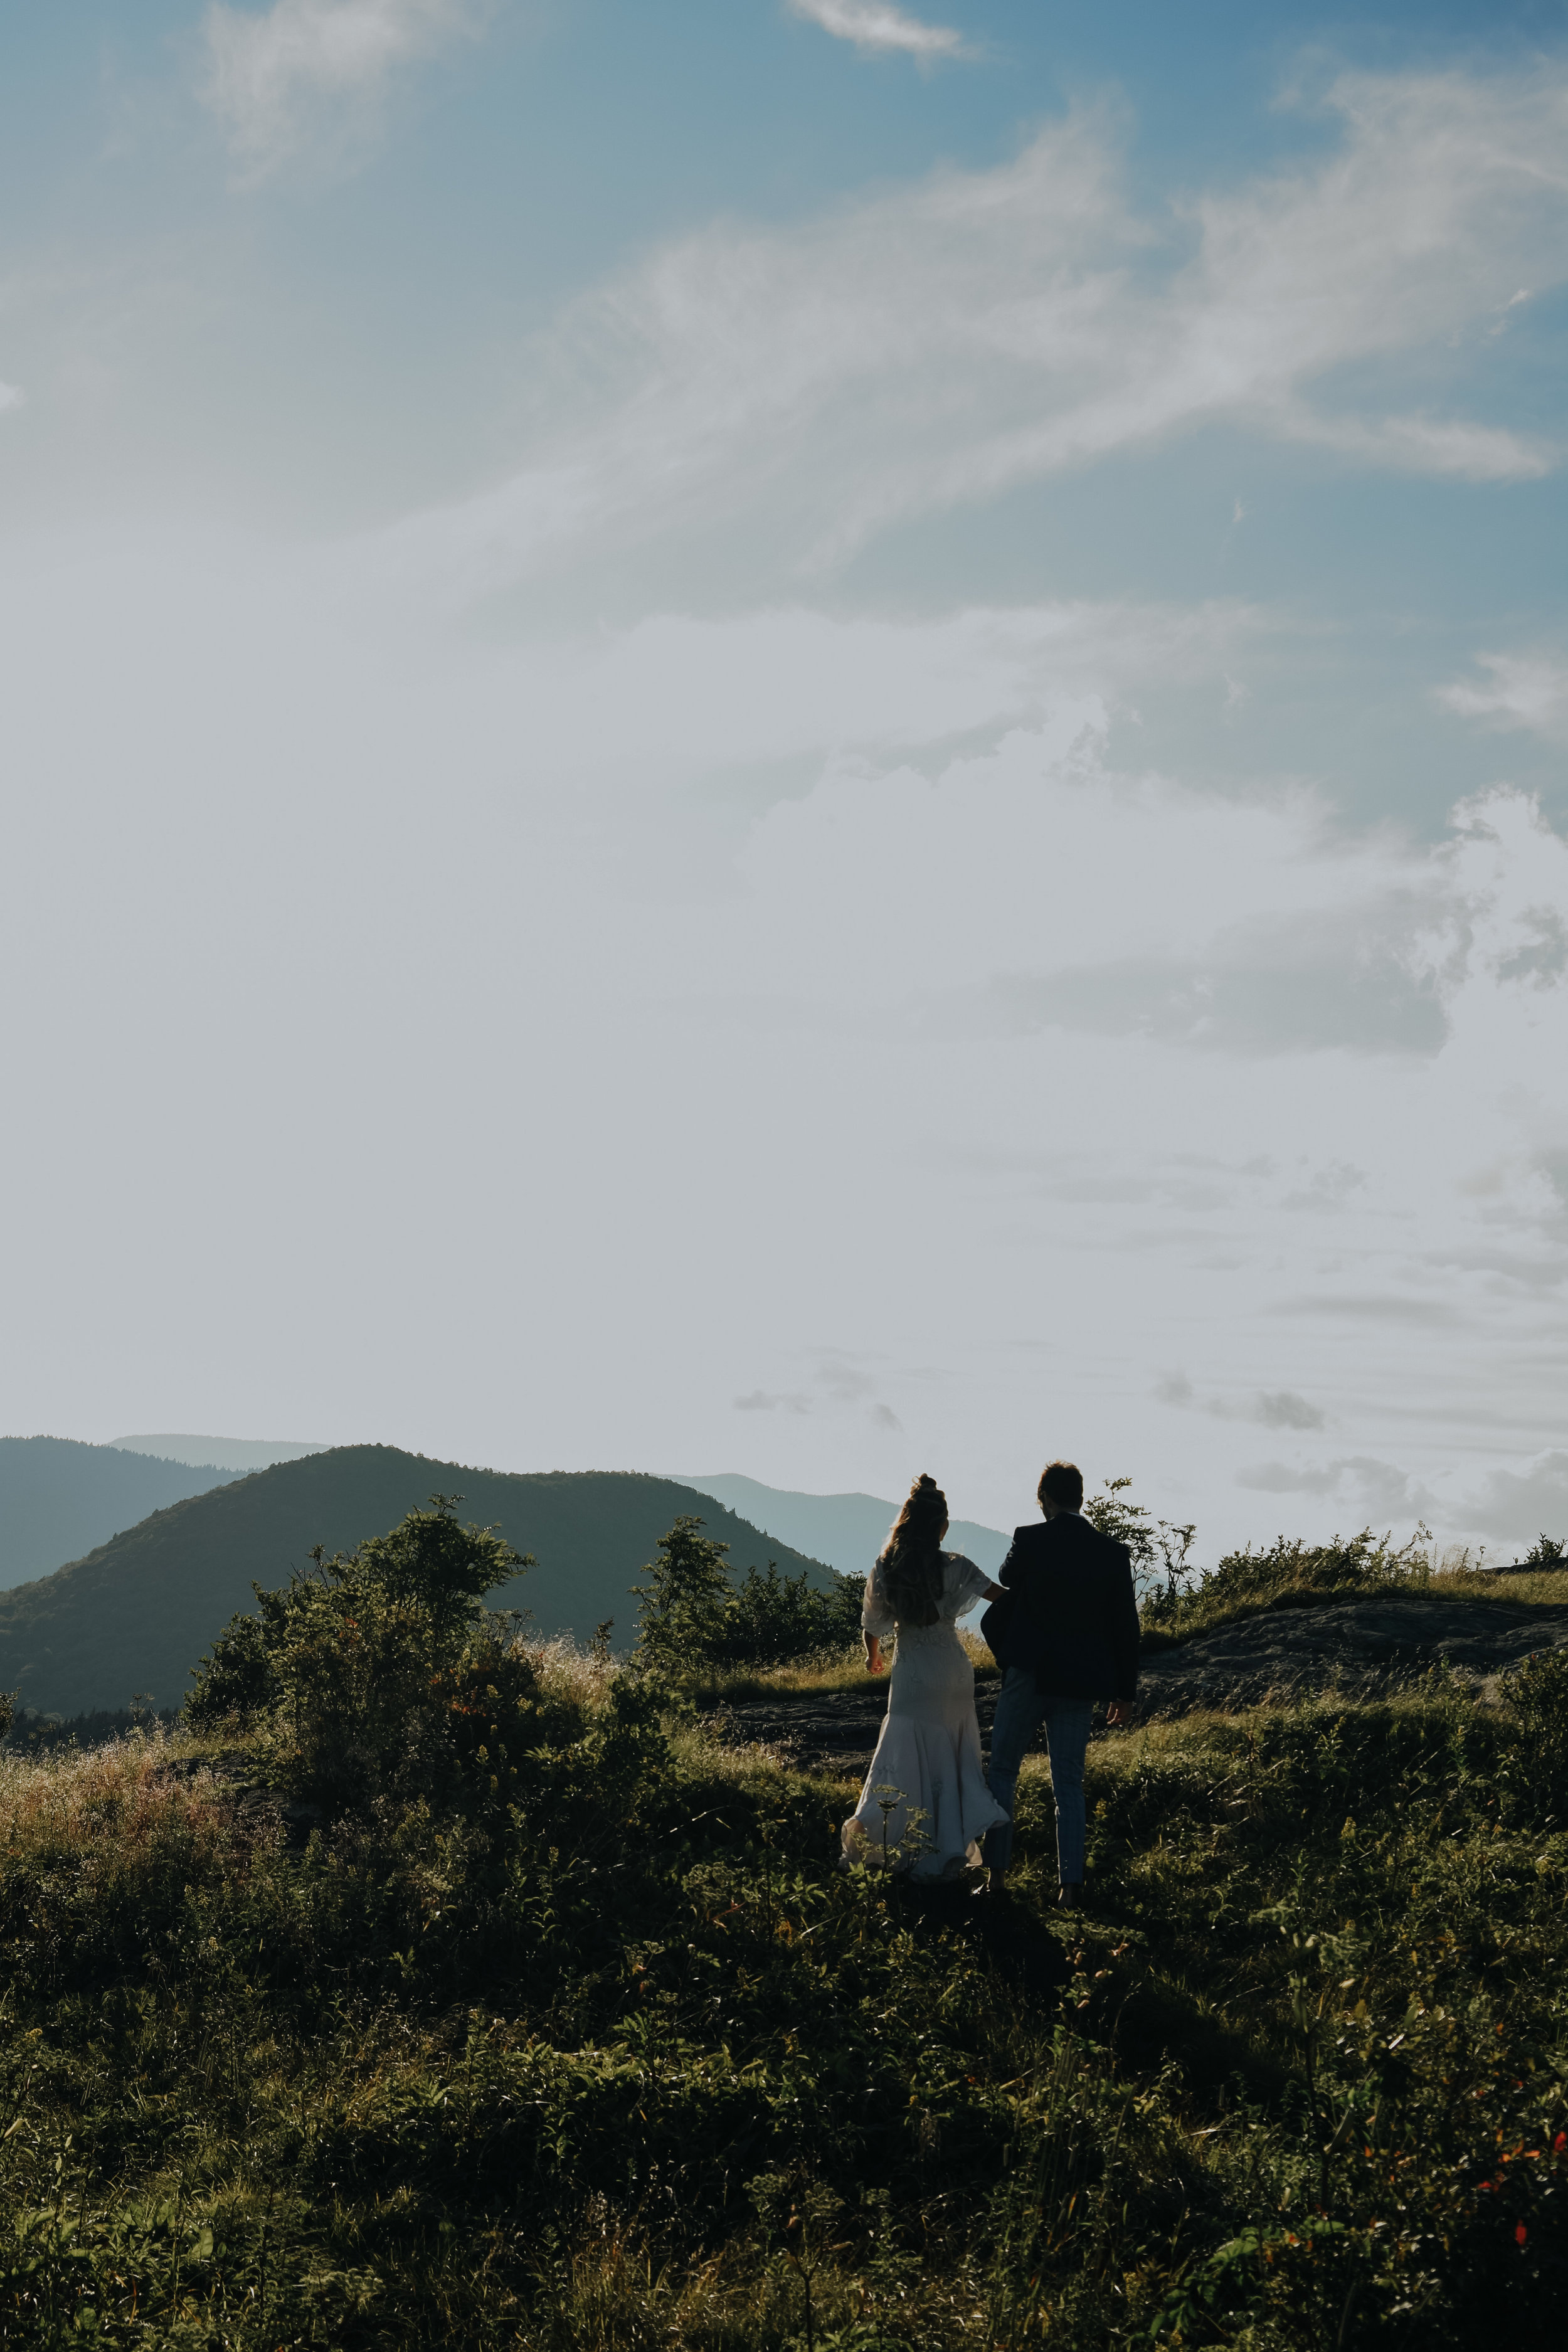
[992,1510,1138,1698]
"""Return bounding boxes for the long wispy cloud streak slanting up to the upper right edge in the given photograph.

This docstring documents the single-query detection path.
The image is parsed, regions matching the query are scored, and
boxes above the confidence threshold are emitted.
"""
[383,66,1568,593]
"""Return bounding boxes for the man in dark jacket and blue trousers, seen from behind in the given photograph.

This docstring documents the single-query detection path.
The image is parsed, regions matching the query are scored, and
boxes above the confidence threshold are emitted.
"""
[980,1463,1138,1910]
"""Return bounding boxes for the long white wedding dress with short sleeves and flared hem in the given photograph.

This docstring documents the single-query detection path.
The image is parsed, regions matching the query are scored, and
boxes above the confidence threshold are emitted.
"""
[844,1552,1009,1879]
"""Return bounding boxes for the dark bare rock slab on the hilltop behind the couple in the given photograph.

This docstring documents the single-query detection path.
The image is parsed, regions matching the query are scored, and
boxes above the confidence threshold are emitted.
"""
[717,1592,1568,1774]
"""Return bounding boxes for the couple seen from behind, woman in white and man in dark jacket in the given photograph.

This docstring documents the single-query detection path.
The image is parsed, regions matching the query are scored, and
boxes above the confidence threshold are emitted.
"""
[844,1463,1138,1905]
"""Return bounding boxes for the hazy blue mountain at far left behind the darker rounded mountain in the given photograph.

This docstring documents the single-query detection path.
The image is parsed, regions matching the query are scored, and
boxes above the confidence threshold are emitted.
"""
[0,1437,233,1590]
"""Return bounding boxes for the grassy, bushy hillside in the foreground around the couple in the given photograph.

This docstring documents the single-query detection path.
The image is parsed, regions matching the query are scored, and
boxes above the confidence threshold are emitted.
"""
[0,1515,1568,2352]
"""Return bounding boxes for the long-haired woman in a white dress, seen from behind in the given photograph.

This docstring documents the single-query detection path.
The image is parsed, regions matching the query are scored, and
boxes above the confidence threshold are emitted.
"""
[844,1477,1009,1879]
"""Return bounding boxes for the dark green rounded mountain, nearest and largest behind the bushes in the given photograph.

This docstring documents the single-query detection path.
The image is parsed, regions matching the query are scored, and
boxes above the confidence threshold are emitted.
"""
[0,1446,832,1715]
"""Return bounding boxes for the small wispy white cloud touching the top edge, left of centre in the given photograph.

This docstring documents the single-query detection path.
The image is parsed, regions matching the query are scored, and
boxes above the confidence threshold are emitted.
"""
[202,0,484,179]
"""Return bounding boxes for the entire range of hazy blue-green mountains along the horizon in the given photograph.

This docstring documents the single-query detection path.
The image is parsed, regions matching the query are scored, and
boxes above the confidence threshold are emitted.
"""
[0,1437,1006,1715]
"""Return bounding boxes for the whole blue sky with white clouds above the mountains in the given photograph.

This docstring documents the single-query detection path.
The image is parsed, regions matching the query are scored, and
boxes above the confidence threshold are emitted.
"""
[0,0,1568,1562]
